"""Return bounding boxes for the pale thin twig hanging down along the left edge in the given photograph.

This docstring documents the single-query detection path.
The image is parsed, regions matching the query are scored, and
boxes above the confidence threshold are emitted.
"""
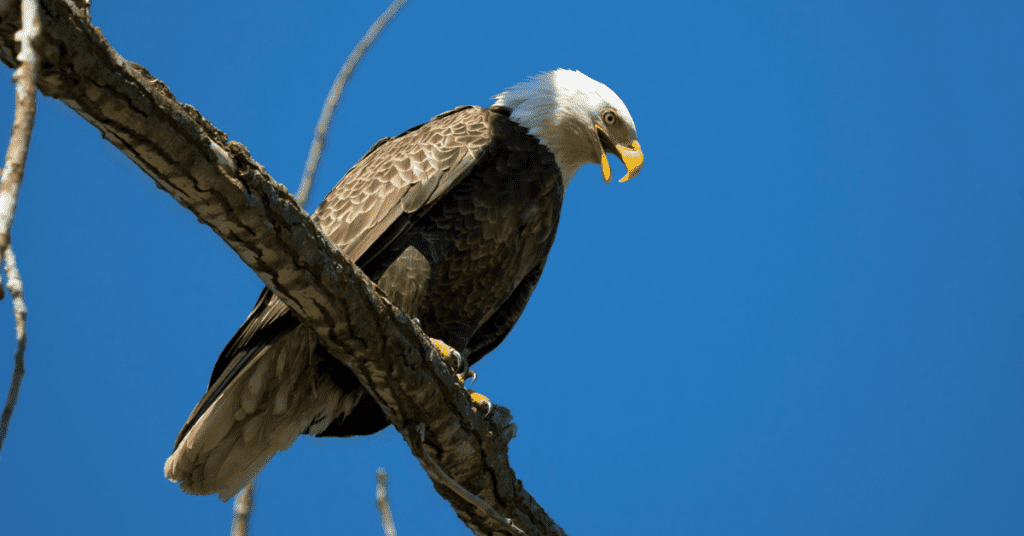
[0,0,40,450]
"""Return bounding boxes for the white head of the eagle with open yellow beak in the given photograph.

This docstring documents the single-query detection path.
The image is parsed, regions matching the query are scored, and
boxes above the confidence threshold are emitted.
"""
[495,69,643,185]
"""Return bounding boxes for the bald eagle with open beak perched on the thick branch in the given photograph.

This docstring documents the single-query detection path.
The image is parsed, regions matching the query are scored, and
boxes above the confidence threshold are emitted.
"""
[164,70,643,500]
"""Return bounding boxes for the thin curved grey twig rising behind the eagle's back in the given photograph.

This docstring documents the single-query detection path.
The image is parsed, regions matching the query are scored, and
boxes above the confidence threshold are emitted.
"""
[295,0,407,207]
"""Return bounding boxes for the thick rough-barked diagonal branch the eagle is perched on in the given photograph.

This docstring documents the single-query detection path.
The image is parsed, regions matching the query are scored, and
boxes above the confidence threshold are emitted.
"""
[0,0,564,534]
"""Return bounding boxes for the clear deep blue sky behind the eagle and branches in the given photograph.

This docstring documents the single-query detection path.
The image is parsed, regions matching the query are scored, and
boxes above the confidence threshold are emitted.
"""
[0,0,1024,536]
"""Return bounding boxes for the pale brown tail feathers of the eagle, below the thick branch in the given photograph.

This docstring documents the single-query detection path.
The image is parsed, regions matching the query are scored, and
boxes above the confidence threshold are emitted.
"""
[164,327,362,501]
